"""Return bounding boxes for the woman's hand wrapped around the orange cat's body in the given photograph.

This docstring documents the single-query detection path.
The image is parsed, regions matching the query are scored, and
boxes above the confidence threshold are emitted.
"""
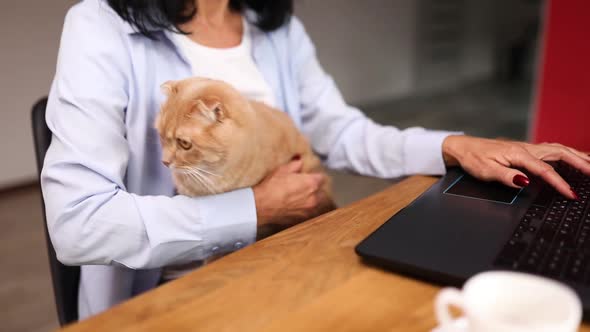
[253,160,325,228]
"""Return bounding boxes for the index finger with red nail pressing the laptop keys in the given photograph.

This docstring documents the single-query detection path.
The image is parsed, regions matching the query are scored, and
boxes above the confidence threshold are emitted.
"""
[510,150,578,199]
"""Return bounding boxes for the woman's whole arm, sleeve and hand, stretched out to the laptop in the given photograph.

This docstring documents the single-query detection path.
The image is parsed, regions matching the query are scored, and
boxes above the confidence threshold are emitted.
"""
[289,18,590,199]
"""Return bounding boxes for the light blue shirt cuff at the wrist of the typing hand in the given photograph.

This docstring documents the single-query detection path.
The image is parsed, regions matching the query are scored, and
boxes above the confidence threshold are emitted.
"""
[404,131,463,175]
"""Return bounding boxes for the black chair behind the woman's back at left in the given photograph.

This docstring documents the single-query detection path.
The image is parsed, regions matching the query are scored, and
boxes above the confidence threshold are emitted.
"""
[31,98,80,326]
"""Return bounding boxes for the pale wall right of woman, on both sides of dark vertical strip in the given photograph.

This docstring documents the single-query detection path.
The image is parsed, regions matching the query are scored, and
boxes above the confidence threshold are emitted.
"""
[295,0,500,104]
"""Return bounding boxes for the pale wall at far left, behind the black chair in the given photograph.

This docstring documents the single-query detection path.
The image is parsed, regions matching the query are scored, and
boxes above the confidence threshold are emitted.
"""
[0,0,77,188]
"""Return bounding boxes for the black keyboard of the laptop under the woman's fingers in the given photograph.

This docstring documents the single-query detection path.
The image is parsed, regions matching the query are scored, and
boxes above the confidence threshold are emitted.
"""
[494,162,590,285]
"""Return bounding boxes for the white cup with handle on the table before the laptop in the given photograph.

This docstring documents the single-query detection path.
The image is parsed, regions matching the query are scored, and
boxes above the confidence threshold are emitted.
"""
[435,271,582,332]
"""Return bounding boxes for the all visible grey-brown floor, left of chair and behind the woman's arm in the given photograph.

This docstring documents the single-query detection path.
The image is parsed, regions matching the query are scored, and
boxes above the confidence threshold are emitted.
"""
[0,82,530,332]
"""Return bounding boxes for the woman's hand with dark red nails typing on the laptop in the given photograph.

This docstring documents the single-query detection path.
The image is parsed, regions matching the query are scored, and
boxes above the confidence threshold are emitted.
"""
[443,136,590,199]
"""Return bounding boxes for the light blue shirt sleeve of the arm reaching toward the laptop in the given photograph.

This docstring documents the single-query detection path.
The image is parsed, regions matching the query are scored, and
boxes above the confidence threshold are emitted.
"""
[290,18,461,178]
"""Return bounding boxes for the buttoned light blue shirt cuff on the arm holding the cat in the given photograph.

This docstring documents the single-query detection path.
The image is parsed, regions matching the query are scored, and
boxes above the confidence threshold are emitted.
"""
[199,188,257,256]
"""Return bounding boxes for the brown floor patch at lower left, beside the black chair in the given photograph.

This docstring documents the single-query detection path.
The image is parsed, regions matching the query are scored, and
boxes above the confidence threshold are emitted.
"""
[0,186,57,332]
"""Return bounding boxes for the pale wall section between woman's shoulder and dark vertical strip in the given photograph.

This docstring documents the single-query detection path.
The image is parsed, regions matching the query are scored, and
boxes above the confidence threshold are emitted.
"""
[295,0,416,104]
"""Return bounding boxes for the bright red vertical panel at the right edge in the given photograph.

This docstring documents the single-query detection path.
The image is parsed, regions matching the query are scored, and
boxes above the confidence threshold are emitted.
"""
[532,0,590,152]
